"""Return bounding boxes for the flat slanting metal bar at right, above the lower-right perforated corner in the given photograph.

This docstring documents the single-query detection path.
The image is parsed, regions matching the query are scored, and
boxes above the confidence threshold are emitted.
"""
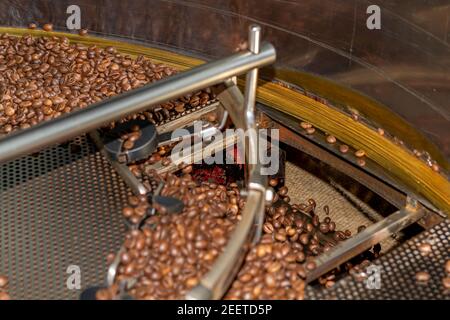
[306,198,425,283]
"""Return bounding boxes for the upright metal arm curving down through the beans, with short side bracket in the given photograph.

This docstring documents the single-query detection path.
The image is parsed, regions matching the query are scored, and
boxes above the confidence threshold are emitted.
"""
[186,25,271,300]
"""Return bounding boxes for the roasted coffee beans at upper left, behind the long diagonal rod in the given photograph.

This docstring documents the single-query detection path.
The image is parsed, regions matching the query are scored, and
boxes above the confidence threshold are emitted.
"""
[0,34,214,135]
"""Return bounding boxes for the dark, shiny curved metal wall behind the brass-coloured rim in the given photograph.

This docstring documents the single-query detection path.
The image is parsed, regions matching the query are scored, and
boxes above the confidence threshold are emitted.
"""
[0,0,450,158]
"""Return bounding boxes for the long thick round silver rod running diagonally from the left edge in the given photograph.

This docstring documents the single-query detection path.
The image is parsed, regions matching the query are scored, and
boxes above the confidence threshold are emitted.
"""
[0,43,276,163]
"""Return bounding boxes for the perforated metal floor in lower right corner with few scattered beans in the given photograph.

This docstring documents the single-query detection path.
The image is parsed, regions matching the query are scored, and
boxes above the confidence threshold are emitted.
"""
[306,219,450,300]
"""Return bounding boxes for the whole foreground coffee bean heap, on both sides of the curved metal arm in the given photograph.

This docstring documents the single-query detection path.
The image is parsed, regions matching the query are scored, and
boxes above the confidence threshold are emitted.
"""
[101,172,362,299]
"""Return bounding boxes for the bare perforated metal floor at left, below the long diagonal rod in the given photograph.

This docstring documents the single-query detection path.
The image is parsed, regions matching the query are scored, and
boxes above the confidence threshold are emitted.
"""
[0,136,129,299]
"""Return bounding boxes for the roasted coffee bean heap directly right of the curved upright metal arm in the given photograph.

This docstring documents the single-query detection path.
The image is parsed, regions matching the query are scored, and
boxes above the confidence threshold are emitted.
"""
[225,179,358,299]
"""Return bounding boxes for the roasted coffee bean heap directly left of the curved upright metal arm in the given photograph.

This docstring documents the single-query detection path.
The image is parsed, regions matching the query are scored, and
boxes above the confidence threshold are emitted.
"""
[97,174,244,299]
